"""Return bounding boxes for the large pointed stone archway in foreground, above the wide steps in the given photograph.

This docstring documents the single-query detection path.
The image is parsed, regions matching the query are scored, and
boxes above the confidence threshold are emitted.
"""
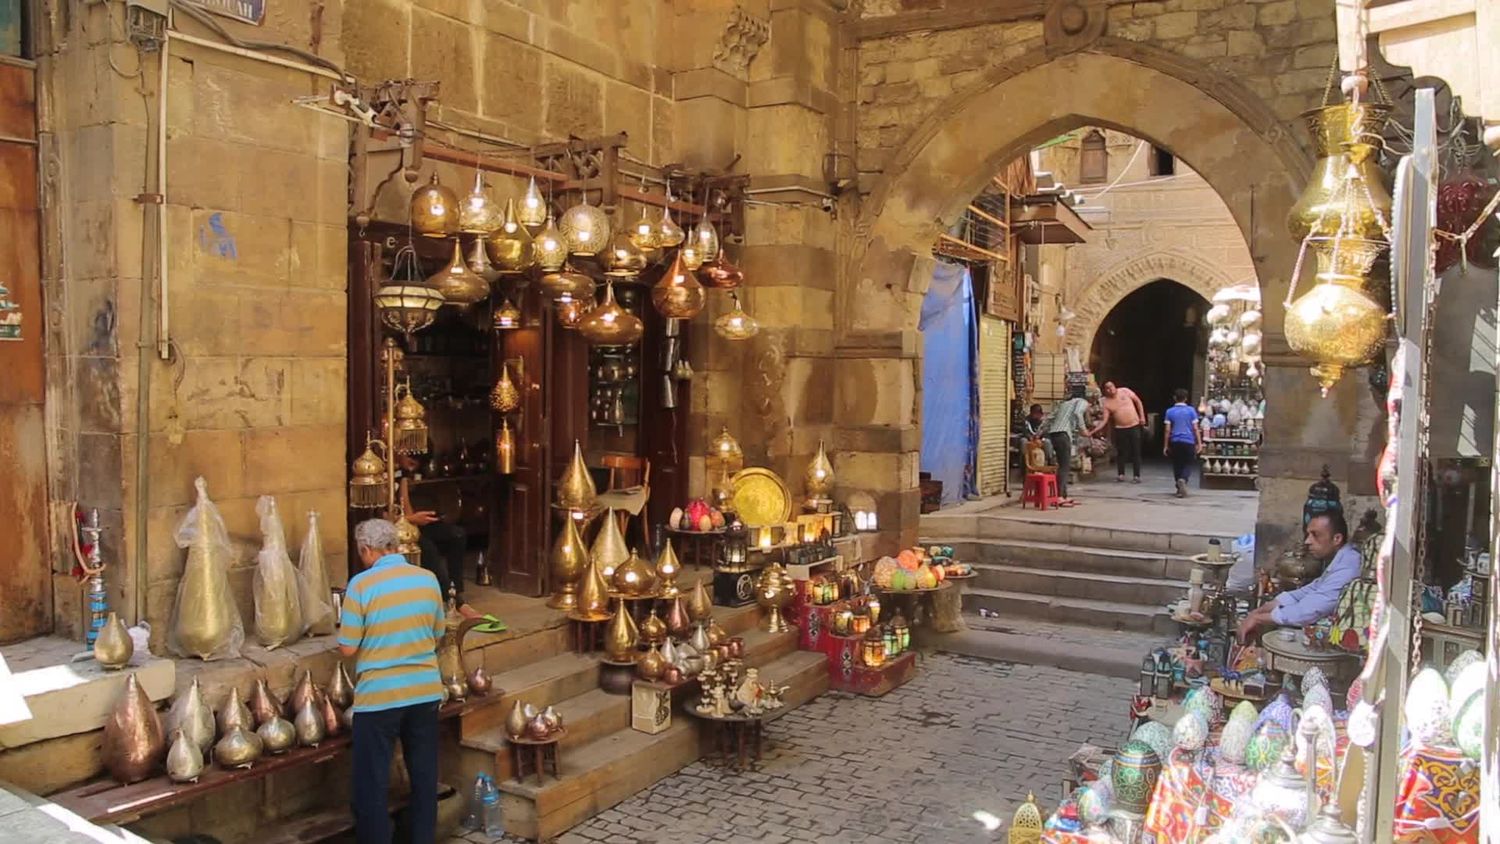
[834,37,1373,553]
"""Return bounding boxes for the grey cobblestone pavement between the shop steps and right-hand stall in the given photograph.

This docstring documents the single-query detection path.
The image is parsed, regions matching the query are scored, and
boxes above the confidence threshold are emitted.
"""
[447,654,1134,844]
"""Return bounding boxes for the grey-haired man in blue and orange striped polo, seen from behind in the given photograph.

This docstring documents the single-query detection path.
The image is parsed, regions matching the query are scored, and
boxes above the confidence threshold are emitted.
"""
[339,519,444,844]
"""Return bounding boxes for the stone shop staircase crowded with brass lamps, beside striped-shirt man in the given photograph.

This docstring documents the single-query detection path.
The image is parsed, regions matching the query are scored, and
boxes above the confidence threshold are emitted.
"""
[459,596,828,841]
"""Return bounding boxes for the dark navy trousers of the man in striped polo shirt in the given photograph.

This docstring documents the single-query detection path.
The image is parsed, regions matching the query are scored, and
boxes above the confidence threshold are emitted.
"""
[354,703,438,844]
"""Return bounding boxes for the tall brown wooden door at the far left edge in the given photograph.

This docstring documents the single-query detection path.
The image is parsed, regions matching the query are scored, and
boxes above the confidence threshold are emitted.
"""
[0,60,53,643]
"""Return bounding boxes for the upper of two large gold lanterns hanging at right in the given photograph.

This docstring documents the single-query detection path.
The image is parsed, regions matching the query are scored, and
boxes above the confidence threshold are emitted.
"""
[1287,102,1391,240]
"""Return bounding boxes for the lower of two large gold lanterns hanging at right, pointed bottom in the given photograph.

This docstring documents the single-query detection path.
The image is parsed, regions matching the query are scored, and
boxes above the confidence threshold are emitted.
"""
[1286,240,1388,396]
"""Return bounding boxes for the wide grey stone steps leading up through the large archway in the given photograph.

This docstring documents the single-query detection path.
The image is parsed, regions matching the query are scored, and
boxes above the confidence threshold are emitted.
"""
[920,511,1214,676]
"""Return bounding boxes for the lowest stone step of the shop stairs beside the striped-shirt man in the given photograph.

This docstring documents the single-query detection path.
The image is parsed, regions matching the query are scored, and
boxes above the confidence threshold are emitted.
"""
[500,650,828,841]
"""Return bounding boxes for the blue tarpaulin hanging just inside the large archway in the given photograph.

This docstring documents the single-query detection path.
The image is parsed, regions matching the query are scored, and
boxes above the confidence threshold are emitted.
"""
[918,264,980,505]
